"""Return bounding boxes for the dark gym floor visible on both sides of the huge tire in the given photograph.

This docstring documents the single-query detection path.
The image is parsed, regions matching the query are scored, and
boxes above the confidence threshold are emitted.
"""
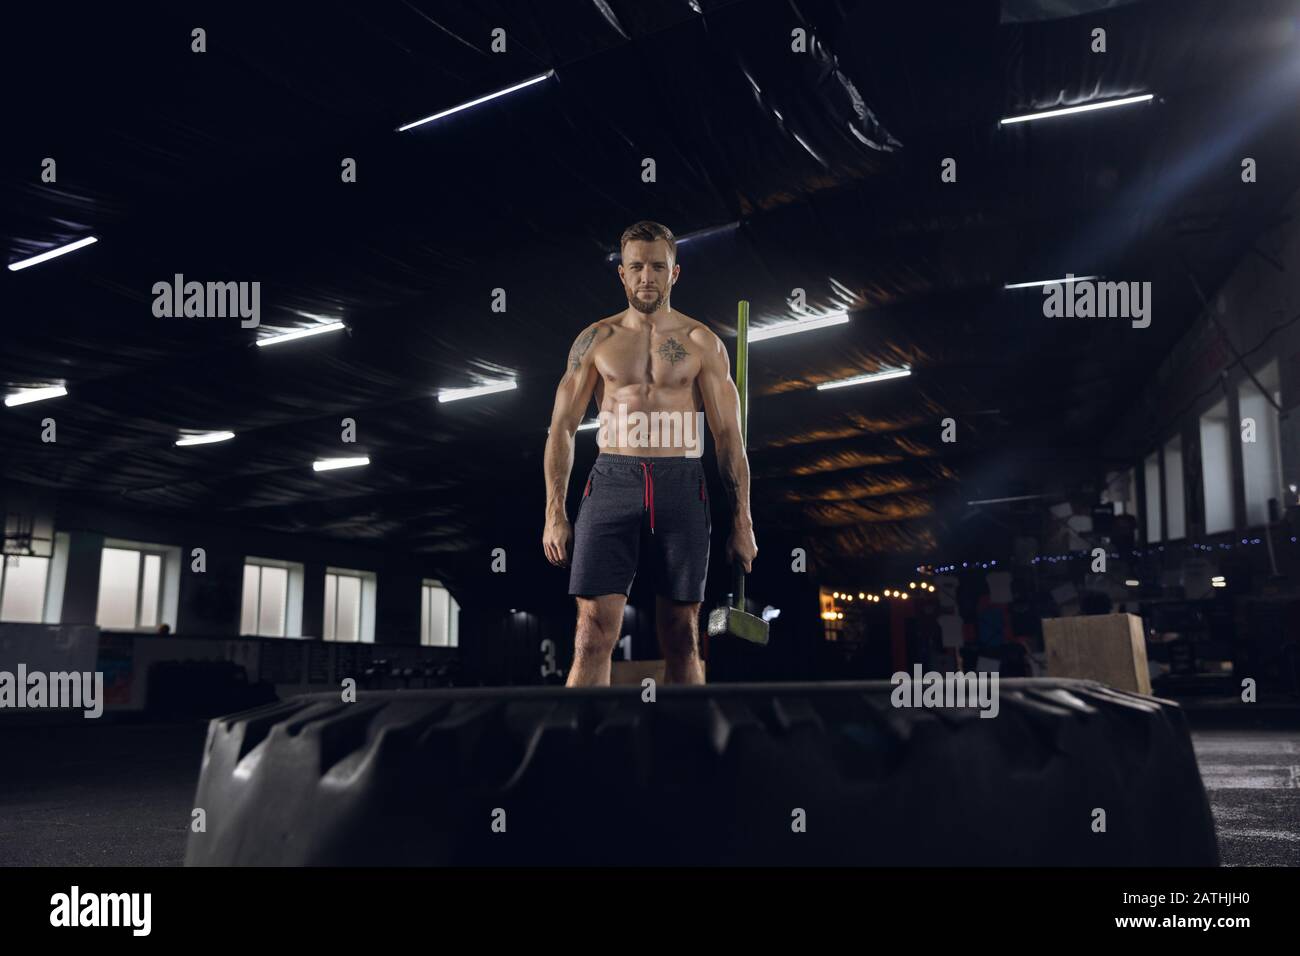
[0,722,1300,866]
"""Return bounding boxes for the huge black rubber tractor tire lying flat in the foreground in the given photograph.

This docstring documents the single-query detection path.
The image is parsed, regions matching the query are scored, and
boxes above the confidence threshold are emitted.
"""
[185,678,1218,866]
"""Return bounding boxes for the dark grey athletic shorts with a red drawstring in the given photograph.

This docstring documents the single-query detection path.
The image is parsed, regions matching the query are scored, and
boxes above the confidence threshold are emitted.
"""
[569,454,712,602]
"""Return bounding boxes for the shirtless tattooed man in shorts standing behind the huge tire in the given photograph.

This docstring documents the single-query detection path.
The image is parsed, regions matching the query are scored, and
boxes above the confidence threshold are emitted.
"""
[542,222,758,687]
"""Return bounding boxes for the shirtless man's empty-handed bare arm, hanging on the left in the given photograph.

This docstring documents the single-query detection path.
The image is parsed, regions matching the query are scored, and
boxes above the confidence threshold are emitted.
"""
[542,324,601,567]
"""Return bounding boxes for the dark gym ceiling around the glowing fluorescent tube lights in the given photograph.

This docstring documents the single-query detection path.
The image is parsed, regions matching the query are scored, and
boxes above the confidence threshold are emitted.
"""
[0,0,1300,606]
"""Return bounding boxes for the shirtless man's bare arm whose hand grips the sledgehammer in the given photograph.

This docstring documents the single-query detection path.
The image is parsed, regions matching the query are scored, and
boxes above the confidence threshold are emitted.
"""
[690,328,758,574]
